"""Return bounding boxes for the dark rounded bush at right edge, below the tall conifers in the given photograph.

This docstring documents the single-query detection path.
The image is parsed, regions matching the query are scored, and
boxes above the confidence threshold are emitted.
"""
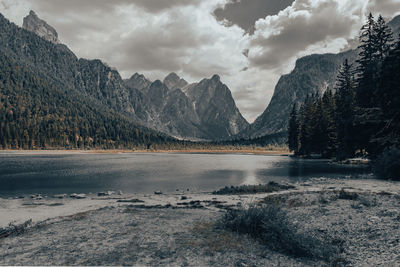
[373,146,400,180]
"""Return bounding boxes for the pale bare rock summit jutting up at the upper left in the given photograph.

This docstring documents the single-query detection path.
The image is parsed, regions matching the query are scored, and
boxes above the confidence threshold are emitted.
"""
[22,10,60,44]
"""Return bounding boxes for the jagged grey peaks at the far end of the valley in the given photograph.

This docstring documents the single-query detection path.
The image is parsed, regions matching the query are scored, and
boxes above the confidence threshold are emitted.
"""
[133,73,248,140]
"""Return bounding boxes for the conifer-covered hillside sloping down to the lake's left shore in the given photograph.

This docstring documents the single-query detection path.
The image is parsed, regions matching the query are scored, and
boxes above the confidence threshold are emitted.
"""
[0,51,175,149]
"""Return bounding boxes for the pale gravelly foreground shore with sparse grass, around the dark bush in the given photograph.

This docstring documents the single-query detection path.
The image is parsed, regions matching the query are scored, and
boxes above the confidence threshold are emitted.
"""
[0,178,400,266]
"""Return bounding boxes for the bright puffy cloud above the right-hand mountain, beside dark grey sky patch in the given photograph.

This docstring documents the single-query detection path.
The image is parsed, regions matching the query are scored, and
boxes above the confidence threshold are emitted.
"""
[249,0,359,72]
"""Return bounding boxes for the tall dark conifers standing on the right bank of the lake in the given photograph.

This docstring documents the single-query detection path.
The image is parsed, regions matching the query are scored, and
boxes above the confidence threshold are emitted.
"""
[288,14,400,178]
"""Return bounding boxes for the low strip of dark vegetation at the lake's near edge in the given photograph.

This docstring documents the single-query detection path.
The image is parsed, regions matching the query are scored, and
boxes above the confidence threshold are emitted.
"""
[213,181,295,195]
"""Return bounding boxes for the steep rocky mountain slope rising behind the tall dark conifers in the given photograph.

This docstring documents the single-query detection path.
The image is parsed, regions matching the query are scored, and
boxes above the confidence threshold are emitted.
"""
[236,16,400,138]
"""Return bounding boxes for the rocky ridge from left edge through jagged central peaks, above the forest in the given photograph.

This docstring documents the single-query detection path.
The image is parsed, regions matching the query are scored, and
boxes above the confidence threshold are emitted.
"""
[0,11,248,140]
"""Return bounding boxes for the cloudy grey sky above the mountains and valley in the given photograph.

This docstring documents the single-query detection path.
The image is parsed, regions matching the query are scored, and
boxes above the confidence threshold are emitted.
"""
[0,0,400,122]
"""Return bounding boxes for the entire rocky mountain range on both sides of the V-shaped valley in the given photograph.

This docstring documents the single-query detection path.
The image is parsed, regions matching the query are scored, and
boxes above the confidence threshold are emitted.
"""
[0,11,400,147]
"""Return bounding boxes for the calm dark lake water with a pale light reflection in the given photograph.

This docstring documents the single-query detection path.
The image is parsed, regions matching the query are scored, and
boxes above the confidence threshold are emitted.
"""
[0,153,369,196]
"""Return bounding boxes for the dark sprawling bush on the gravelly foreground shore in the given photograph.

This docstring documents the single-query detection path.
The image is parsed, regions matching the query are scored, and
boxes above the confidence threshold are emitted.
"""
[217,206,339,260]
